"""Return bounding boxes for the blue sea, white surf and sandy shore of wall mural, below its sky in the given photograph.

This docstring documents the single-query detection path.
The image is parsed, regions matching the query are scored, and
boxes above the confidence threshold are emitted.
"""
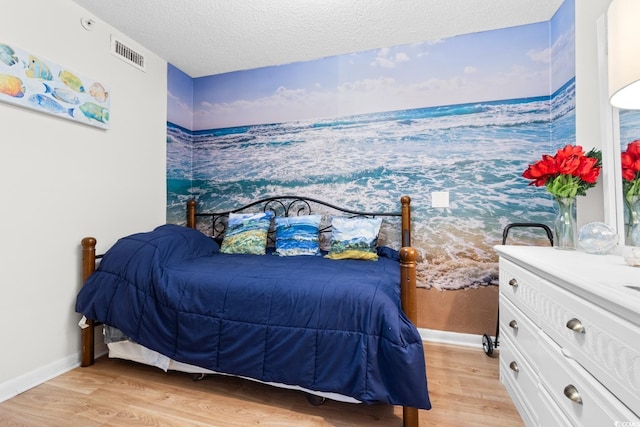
[168,79,575,289]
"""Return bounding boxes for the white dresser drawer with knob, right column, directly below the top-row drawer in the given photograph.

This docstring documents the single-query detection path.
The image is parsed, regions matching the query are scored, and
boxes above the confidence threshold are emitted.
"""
[538,333,640,426]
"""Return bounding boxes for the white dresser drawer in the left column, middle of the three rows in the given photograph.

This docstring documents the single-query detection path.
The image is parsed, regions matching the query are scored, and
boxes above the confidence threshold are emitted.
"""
[500,295,540,365]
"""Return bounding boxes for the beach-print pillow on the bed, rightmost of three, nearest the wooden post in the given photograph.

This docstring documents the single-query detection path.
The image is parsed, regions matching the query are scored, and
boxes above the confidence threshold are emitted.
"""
[325,217,382,261]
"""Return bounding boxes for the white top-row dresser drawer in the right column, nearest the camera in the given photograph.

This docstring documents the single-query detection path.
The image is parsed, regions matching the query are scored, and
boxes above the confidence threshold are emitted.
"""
[539,280,640,415]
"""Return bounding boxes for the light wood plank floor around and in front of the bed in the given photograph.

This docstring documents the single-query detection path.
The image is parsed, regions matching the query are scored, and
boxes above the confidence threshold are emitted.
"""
[0,343,523,427]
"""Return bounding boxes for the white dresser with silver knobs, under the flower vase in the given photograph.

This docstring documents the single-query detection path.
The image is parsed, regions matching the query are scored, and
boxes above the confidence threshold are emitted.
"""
[496,246,640,427]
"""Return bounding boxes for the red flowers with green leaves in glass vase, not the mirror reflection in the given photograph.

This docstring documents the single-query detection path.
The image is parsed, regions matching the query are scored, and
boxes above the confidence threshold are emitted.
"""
[522,144,604,198]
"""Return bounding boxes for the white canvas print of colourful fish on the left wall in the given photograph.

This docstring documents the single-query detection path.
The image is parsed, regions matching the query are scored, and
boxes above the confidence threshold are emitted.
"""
[0,40,111,129]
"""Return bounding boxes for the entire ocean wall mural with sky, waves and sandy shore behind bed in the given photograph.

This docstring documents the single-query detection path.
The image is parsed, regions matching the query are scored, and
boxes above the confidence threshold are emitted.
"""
[167,1,575,289]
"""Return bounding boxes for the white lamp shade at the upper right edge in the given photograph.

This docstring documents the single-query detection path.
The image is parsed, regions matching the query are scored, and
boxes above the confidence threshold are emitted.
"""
[607,0,640,110]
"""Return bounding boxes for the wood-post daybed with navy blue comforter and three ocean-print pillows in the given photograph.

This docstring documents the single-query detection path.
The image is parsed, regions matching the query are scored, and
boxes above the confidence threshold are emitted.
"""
[75,196,431,426]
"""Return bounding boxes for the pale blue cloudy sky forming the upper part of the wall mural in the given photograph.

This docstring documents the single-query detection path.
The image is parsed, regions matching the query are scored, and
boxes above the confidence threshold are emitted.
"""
[169,2,575,130]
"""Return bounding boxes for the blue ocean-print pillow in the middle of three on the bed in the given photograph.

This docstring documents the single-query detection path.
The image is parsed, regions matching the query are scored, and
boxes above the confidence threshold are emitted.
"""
[274,215,322,256]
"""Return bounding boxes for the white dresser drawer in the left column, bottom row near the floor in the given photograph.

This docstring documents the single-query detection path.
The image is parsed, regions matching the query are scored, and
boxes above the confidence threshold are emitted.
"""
[500,337,540,426]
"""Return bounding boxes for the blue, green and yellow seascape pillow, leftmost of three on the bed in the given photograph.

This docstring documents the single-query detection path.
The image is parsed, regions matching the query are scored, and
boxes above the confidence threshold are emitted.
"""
[220,211,273,255]
